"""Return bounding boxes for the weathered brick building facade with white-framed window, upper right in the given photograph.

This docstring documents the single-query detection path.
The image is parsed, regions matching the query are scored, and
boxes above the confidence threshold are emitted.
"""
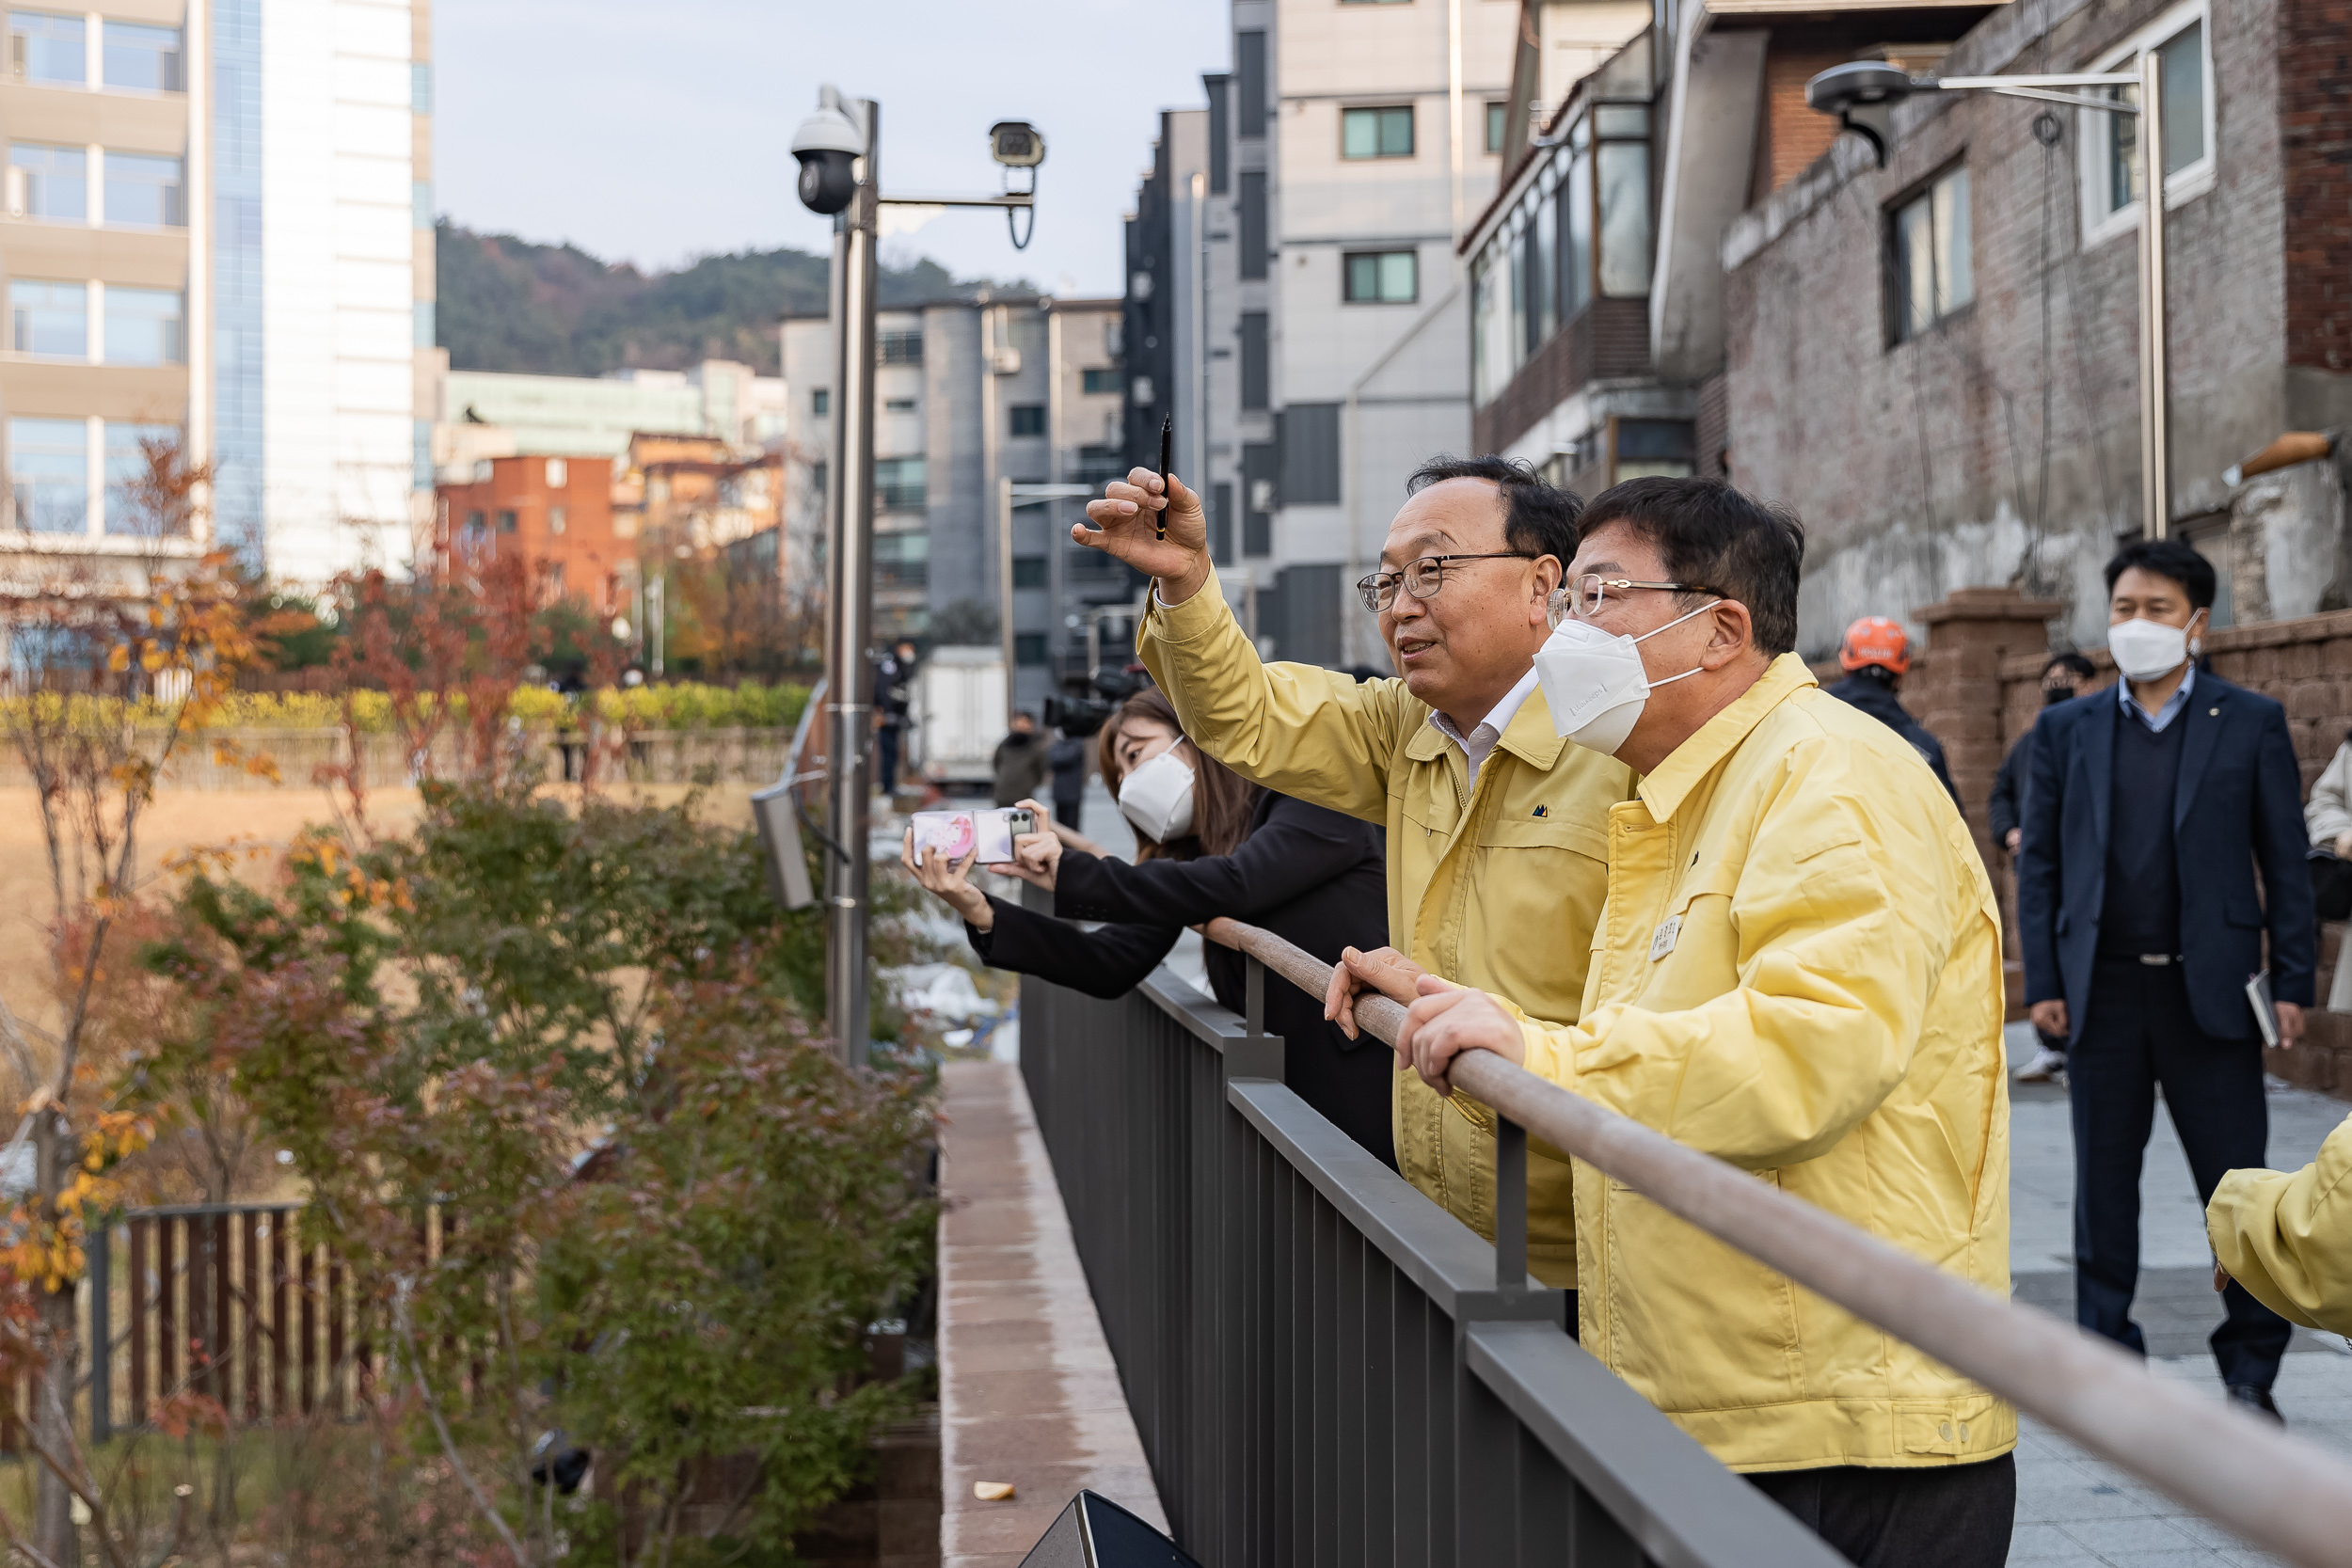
[1703,0,2352,654]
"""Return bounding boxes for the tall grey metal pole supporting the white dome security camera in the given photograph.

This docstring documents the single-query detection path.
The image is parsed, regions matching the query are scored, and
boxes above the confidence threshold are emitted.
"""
[826,99,882,1065]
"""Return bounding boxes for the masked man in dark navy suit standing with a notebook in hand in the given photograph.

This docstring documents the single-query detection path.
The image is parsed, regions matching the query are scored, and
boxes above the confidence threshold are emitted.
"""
[2018,541,2317,1418]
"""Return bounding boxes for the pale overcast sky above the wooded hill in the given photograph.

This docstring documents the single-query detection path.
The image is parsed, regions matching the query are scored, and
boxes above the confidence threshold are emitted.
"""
[433,0,1231,293]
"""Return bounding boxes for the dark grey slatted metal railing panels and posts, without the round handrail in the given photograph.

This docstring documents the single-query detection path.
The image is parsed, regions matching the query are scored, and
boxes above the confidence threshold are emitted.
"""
[1021,944,1839,1568]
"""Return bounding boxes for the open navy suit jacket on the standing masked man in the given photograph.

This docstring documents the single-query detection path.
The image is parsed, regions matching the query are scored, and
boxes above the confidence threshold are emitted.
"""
[2018,670,2319,1039]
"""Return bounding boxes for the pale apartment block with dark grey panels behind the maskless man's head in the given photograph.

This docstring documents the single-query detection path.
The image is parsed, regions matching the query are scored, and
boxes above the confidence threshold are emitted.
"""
[1129,0,1649,663]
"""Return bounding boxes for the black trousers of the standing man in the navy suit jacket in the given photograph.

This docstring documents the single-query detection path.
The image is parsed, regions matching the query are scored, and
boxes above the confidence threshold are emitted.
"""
[2068,959,2294,1389]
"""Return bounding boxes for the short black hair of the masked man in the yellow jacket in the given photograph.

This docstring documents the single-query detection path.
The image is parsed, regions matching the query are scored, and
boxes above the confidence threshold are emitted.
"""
[1583,477,1804,658]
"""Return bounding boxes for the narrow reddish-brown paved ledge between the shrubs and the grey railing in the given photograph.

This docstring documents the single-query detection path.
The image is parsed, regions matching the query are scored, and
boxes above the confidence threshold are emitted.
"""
[939,1063,1167,1568]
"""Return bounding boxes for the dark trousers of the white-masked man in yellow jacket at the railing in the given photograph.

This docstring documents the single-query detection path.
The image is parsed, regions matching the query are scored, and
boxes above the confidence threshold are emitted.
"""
[1748,1453,2018,1568]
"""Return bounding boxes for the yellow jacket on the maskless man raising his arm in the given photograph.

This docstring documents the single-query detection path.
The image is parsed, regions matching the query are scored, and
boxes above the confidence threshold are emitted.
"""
[1136,578,1632,1286]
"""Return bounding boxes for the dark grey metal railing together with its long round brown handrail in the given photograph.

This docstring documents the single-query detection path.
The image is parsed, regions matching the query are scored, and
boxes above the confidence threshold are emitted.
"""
[1021,922,2352,1568]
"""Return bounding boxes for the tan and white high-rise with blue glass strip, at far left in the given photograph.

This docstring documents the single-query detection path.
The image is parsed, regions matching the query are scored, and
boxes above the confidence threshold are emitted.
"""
[0,0,433,594]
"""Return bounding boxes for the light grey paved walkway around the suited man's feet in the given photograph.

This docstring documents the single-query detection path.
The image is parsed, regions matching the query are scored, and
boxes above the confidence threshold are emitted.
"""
[2009,1025,2352,1568]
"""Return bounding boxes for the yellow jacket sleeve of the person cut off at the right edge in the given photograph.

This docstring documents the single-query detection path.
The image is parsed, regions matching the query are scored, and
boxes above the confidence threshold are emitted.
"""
[2206,1104,2352,1336]
